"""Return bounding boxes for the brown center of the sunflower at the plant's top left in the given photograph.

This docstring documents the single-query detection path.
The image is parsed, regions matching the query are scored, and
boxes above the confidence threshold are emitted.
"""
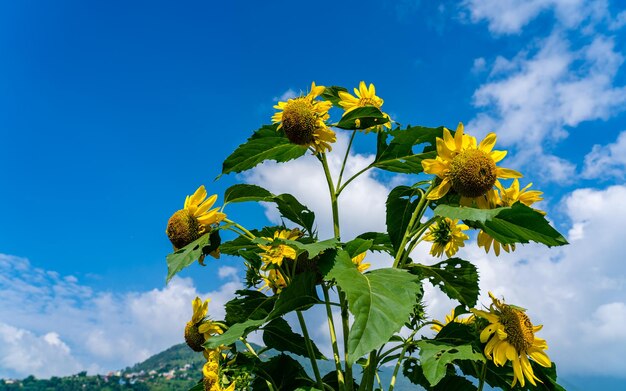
[282,97,317,145]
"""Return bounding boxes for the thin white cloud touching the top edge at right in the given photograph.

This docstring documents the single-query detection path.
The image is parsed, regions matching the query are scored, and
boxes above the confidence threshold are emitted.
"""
[463,0,608,34]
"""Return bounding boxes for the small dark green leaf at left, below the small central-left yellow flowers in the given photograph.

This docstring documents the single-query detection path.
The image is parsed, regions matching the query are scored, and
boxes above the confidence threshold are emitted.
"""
[225,289,276,324]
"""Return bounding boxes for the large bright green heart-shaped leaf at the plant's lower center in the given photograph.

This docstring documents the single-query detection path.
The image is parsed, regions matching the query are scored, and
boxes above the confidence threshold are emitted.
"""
[327,250,422,365]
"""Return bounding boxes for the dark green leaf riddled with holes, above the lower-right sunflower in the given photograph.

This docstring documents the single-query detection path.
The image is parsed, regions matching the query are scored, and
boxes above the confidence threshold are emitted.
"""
[410,258,480,307]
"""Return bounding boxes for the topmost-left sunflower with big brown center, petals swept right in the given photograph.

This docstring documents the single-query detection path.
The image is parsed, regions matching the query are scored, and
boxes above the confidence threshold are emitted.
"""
[272,82,337,153]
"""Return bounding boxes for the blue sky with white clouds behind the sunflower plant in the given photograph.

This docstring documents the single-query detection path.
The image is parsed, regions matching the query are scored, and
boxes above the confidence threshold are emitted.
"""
[0,0,626,388]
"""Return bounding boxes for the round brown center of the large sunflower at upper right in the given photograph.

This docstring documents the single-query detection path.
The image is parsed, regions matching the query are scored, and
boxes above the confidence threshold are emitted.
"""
[448,149,497,198]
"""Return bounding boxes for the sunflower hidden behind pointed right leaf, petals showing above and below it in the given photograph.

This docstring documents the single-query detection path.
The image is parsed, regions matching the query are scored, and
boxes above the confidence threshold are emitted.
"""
[476,179,545,256]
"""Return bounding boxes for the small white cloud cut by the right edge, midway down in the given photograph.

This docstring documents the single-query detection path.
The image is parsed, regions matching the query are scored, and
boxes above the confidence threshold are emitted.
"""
[583,131,626,179]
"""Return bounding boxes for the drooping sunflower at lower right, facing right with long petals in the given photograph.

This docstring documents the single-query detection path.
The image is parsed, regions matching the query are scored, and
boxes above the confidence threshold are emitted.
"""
[471,292,552,387]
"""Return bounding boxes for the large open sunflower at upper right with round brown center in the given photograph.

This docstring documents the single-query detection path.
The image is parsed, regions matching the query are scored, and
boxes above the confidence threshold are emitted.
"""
[422,123,522,203]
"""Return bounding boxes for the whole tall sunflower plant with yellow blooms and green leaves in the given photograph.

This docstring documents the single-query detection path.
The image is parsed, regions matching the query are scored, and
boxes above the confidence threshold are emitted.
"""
[166,82,567,391]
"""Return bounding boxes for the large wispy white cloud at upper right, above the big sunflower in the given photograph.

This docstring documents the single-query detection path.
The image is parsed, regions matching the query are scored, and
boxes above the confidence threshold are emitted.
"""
[468,32,626,182]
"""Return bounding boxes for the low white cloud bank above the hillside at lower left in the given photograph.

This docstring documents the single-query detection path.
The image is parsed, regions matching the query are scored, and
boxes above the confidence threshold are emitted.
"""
[0,254,242,377]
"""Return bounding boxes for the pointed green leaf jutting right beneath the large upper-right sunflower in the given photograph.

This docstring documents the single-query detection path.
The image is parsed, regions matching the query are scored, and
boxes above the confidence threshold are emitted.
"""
[464,202,567,246]
